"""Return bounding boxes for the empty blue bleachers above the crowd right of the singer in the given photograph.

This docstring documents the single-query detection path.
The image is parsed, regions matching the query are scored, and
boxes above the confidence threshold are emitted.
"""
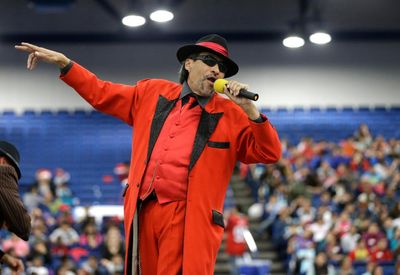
[262,106,400,144]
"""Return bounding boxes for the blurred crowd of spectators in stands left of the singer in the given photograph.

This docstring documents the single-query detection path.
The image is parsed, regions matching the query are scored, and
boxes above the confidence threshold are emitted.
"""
[0,168,125,275]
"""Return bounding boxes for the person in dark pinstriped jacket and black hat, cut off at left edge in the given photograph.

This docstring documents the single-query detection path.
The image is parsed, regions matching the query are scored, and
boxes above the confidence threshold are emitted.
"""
[0,141,31,274]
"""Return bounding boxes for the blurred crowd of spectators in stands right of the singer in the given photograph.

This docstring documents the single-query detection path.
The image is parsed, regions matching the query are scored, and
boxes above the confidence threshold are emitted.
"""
[242,124,400,275]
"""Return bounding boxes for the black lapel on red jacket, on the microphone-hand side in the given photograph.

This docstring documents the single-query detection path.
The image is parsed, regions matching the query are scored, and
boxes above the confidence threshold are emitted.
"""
[189,110,224,171]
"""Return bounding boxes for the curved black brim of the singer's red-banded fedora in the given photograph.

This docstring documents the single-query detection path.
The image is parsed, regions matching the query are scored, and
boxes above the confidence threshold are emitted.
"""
[176,45,239,77]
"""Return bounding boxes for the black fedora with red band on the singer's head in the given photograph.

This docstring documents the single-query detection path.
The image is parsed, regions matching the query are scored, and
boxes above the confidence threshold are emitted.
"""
[176,34,239,77]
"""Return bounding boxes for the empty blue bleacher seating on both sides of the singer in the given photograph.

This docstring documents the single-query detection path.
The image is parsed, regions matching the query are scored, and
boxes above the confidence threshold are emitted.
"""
[0,106,400,204]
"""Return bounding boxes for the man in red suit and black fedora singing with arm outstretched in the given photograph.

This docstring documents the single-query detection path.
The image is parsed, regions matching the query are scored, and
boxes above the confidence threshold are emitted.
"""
[16,34,281,275]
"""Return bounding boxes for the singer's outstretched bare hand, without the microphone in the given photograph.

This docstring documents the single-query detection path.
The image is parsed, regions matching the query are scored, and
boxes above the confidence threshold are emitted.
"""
[15,42,70,70]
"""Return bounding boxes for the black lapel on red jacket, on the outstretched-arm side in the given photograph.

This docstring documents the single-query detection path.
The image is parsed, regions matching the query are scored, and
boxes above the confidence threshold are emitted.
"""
[147,95,179,161]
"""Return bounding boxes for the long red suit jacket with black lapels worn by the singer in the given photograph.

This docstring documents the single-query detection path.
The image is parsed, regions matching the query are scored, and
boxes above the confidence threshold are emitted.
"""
[61,63,281,275]
